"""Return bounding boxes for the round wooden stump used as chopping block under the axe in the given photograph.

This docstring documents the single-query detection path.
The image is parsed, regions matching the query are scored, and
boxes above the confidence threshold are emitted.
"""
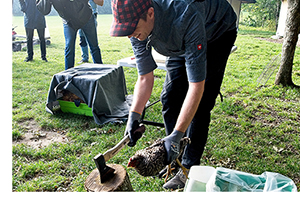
[84,164,133,192]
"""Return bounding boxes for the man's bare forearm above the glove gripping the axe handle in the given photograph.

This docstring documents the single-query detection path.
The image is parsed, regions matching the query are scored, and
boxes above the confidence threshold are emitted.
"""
[131,72,154,113]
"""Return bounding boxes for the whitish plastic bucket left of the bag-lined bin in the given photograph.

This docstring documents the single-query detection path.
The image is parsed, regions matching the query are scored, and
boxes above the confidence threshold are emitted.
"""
[184,166,216,192]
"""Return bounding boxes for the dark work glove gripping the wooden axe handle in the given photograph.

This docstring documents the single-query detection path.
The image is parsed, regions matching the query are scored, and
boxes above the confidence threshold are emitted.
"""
[124,111,142,147]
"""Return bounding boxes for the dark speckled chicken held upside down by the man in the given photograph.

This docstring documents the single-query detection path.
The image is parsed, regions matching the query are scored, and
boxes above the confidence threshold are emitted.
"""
[127,137,190,181]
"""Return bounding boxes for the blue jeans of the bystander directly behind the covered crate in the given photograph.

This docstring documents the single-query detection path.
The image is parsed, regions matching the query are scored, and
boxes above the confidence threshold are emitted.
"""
[64,15,102,69]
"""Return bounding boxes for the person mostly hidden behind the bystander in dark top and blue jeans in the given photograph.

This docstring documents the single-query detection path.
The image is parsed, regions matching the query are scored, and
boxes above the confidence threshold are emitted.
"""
[78,0,103,64]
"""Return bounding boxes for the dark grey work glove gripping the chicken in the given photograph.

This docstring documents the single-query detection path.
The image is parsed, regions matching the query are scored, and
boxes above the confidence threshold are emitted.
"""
[162,129,184,165]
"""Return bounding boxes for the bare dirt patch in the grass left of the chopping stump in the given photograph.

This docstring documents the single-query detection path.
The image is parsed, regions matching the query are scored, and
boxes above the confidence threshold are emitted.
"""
[13,120,68,149]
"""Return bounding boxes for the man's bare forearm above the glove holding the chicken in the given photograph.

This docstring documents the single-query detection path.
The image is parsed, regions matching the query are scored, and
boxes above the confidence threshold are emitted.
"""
[175,81,205,132]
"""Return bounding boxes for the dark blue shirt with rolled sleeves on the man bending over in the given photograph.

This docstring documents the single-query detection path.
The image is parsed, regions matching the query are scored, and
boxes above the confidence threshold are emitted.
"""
[130,0,237,82]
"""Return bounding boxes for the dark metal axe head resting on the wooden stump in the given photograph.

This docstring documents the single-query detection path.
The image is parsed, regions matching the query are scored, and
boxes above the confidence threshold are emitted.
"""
[94,154,115,183]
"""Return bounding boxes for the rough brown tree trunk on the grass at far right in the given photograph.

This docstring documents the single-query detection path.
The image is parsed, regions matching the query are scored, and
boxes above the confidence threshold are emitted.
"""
[275,0,300,86]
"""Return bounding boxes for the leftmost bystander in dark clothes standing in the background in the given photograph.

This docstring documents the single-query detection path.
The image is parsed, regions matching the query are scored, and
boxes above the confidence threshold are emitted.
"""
[19,0,48,62]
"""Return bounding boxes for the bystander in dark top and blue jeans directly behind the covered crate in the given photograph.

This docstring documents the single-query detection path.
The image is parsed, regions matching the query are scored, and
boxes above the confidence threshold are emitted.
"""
[36,0,103,70]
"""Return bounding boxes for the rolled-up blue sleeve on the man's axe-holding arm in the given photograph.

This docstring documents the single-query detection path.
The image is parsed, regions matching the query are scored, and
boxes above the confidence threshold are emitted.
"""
[130,37,157,75]
